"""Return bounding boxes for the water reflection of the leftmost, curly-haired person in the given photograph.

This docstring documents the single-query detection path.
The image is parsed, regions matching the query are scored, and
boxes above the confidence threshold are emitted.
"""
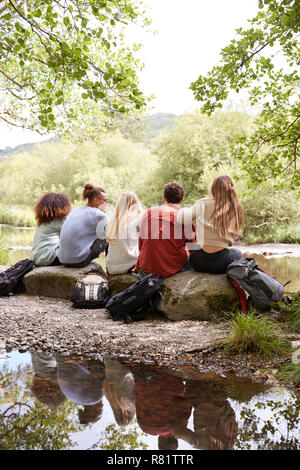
[30,353,66,407]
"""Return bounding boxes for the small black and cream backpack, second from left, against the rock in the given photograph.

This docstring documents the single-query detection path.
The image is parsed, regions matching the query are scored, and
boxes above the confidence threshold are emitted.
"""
[71,271,109,308]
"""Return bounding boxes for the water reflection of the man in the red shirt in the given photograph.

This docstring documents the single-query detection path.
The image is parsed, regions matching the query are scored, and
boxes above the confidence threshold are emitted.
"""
[134,371,192,450]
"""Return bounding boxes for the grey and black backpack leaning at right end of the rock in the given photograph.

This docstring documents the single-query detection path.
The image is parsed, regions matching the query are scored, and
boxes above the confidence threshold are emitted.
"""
[227,258,284,313]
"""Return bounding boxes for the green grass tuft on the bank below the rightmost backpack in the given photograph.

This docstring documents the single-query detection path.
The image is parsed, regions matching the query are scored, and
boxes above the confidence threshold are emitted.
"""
[223,311,290,357]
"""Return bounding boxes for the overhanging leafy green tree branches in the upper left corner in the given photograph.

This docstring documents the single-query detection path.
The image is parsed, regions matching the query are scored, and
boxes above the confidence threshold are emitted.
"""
[0,0,148,133]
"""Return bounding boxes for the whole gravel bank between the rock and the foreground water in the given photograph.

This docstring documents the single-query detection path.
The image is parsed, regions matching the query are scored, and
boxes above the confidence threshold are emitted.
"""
[0,294,296,383]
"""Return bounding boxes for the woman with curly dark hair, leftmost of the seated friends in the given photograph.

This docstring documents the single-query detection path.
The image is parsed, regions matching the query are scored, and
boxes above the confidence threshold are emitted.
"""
[30,193,72,266]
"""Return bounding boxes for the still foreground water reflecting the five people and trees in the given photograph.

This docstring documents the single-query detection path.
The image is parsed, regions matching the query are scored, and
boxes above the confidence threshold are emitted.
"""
[0,351,300,450]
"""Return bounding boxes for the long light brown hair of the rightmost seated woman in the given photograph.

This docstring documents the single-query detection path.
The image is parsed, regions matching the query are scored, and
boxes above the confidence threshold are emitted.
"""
[210,176,244,237]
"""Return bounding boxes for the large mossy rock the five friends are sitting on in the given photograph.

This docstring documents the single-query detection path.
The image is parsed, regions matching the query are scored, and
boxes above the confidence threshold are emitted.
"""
[0,263,239,321]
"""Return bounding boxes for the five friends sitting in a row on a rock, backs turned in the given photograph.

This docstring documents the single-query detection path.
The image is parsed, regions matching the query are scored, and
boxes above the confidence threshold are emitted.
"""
[30,176,244,277]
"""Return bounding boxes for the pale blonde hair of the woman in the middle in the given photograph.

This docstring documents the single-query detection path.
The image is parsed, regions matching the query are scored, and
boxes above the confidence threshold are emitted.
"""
[106,191,143,244]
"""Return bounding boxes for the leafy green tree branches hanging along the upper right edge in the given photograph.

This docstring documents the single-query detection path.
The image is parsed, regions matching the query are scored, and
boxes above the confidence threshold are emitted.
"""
[191,0,300,188]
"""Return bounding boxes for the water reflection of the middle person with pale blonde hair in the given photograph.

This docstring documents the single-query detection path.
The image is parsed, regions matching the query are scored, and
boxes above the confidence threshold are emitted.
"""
[104,359,135,426]
